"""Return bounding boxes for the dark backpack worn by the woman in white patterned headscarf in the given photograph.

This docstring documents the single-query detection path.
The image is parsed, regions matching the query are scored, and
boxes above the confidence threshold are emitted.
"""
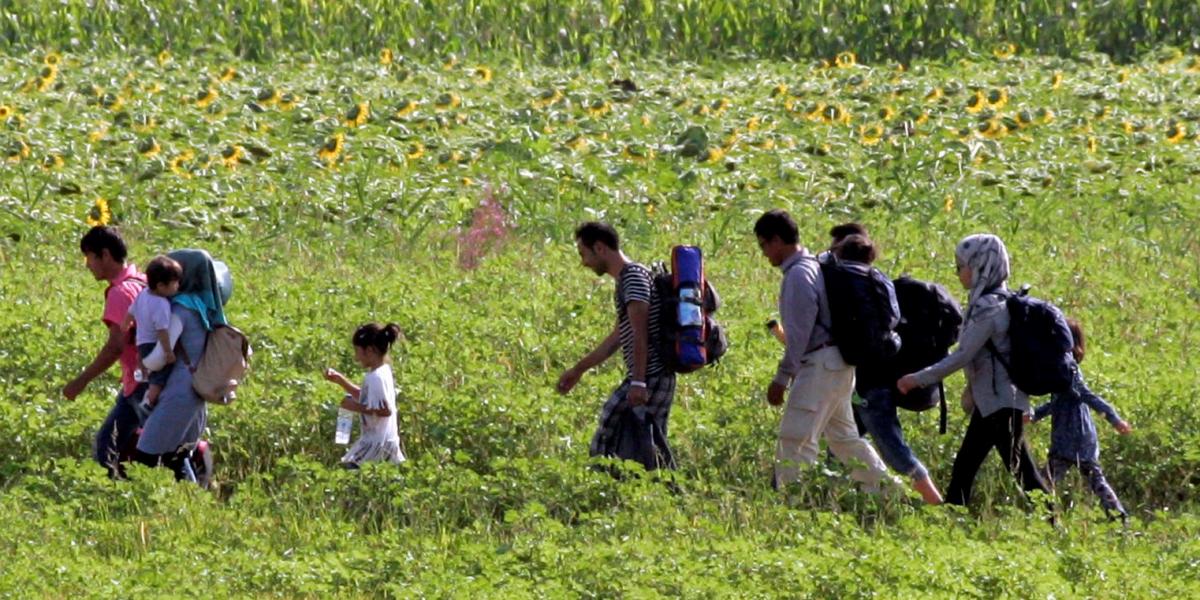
[988,286,1075,396]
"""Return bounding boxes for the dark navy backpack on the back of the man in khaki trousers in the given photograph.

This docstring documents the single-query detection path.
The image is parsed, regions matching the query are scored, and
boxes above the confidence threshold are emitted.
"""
[818,254,900,366]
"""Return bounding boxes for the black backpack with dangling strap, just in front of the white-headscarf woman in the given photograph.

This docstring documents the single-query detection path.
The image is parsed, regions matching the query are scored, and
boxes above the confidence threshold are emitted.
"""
[888,276,962,433]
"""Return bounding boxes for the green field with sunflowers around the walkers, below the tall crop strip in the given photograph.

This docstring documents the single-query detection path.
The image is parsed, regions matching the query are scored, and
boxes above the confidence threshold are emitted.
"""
[0,2,1200,598]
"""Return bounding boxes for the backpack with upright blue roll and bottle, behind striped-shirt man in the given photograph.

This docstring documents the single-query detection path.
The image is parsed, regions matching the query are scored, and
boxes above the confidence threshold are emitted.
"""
[652,246,730,373]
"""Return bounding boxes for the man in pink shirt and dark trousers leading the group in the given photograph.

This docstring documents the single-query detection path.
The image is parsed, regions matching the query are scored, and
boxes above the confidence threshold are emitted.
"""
[62,226,146,476]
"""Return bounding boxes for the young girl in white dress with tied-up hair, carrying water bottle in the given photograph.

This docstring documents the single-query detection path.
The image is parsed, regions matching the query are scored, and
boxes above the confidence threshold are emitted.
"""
[325,323,404,469]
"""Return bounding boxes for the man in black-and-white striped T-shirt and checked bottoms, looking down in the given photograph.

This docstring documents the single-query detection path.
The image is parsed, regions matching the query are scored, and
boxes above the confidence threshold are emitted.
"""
[557,222,676,463]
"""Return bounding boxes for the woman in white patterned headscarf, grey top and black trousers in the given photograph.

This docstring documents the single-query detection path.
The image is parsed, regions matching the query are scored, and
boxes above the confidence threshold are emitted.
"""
[896,234,1049,504]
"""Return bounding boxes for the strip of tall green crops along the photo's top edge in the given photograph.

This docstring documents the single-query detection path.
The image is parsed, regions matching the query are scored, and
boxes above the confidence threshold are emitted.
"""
[0,0,1200,62]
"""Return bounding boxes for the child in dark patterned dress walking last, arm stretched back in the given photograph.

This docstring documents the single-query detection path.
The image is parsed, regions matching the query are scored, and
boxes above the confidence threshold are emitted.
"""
[1026,319,1133,521]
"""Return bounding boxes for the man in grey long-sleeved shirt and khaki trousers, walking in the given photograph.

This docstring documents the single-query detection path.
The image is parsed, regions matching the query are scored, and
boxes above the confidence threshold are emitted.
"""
[754,209,888,490]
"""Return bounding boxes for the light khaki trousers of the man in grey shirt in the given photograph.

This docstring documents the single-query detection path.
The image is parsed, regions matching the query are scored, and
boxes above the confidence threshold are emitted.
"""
[775,347,888,490]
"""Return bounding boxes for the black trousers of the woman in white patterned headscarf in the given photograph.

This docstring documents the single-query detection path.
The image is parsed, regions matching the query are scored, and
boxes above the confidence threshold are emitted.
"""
[946,408,1050,505]
